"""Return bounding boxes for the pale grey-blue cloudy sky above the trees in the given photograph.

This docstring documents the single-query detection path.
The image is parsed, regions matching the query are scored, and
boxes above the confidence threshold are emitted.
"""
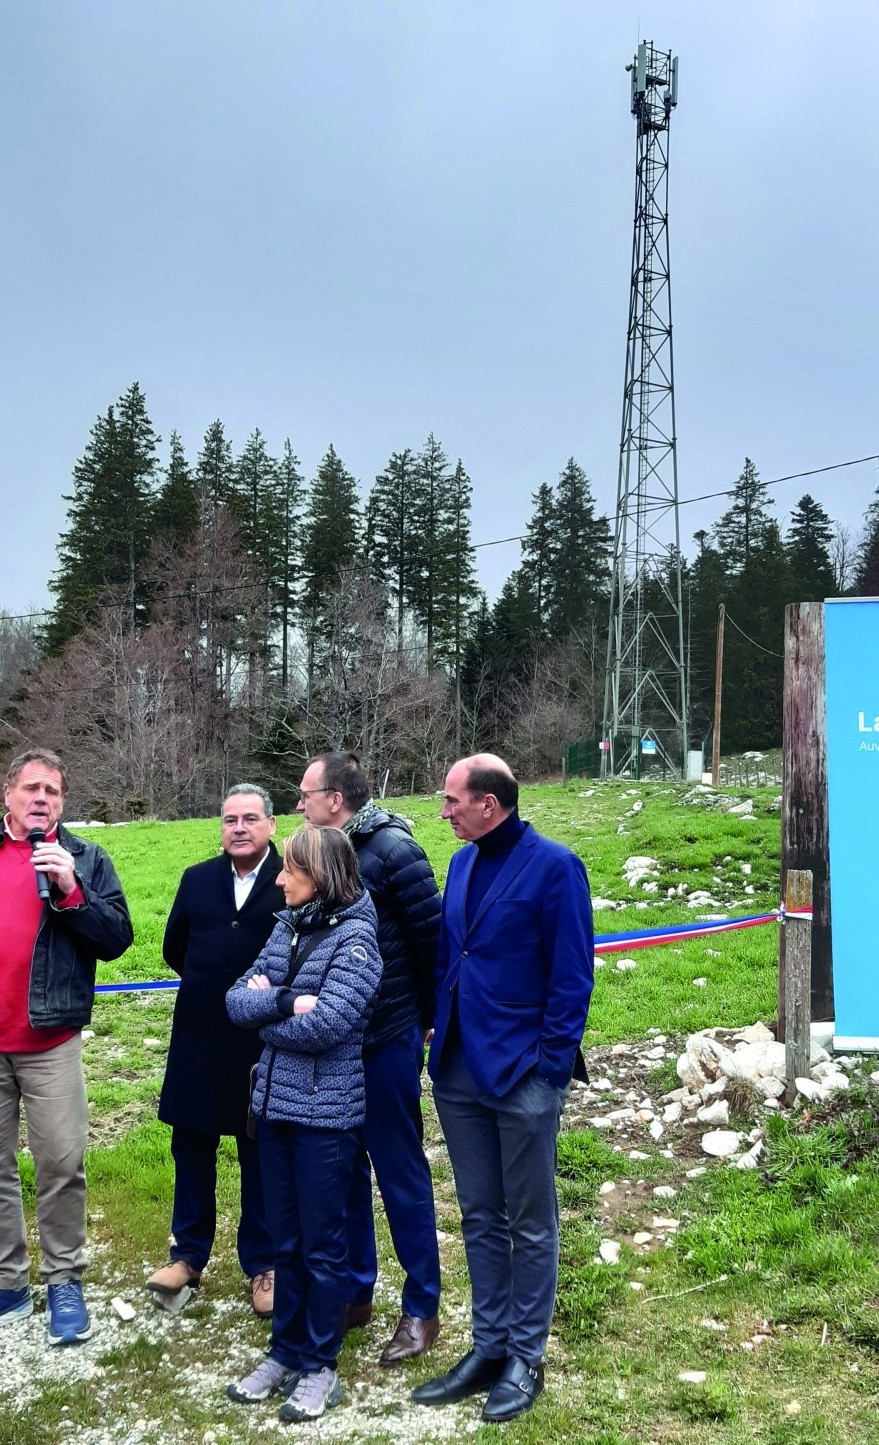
[0,0,879,613]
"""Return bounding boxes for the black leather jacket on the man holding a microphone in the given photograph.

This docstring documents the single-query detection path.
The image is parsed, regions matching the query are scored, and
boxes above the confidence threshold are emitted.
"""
[0,827,134,1029]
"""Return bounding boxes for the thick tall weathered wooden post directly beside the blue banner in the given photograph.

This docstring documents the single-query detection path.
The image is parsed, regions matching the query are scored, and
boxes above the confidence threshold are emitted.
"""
[778,603,833,1039]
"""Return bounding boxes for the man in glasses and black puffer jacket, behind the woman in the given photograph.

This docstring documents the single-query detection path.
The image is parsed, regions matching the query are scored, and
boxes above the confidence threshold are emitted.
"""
[298,753,441,1366]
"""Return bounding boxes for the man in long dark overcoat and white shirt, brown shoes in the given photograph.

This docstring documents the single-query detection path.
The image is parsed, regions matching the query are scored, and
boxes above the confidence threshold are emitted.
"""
[146,783,283,1318]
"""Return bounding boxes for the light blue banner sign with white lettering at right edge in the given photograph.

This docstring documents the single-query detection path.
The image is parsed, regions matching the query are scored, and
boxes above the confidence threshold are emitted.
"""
[824,597,879,1051]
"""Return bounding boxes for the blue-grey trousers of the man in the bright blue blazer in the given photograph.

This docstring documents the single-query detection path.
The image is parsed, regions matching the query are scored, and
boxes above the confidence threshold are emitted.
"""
[434,1049,567,1364]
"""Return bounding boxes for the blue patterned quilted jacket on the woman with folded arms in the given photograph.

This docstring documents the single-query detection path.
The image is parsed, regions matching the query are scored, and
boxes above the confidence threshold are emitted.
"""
[226,893,382,1129]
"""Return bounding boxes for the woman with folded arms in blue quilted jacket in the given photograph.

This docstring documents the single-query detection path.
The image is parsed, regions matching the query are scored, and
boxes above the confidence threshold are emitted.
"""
[226,825,382,1420]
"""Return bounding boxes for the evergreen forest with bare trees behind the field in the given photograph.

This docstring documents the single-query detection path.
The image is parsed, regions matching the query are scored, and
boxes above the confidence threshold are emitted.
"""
[0,383,879,822]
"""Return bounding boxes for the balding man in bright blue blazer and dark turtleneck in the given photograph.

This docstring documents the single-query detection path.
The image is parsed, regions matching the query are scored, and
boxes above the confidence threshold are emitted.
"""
[412,753,593,1422]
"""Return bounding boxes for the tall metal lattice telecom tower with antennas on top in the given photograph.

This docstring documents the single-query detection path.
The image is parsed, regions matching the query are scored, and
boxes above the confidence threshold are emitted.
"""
[601,40,687,777]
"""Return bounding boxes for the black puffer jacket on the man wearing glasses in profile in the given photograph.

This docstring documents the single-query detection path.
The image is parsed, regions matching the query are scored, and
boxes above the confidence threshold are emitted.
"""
[350,808,442,1051]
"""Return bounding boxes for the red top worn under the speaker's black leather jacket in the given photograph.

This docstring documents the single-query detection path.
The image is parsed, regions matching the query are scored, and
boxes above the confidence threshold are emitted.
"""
[0,824,85,1053]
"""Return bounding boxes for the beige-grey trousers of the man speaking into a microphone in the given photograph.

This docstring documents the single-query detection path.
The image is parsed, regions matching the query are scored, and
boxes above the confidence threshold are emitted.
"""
[0,1033,88,1289]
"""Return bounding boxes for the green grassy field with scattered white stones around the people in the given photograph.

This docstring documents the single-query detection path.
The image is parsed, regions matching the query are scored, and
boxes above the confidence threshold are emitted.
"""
[6,785,879,1445]
